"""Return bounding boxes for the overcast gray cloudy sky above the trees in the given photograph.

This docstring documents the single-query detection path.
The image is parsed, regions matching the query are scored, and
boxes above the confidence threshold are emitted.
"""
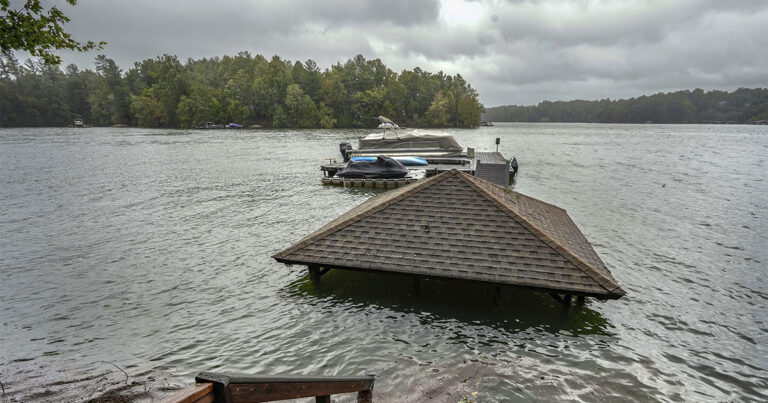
[52,0,768,106]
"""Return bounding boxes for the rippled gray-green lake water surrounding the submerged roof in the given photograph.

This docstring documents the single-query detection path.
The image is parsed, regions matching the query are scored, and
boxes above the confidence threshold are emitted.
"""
[0,124,768,401]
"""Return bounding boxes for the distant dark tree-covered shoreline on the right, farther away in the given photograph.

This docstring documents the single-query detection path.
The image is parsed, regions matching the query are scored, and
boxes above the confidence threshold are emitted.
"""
[483,88,768,123]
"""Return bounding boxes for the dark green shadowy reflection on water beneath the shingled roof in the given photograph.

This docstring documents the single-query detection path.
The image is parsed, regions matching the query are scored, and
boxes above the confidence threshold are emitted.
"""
[284,266,611,340]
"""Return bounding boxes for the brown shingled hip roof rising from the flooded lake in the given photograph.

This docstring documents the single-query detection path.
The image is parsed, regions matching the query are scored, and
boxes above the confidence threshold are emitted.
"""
[272,170,624,298]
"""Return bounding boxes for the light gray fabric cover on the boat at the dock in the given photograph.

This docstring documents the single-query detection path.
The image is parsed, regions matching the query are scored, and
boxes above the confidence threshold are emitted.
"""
[360,130,462,151]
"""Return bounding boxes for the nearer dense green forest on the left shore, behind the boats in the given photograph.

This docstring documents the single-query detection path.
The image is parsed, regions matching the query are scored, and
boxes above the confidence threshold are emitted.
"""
[0,52,482,128]
